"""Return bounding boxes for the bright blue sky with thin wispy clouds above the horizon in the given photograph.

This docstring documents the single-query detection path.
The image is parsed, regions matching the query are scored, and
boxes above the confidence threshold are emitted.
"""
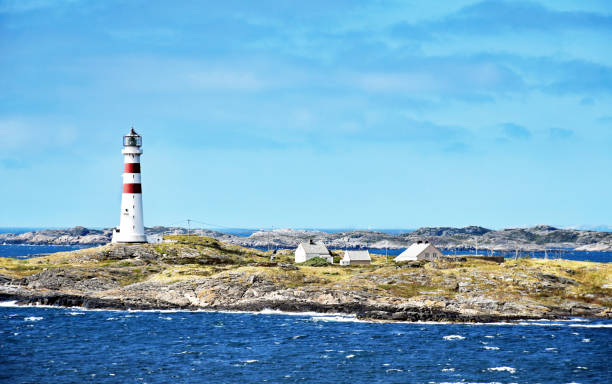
[0,0,612,228]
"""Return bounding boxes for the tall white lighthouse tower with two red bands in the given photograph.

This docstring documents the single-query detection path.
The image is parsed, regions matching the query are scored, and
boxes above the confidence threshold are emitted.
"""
[113,128,147,243]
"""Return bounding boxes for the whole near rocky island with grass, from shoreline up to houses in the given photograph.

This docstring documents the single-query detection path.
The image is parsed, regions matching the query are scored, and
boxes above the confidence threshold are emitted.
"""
[0,235,612,322]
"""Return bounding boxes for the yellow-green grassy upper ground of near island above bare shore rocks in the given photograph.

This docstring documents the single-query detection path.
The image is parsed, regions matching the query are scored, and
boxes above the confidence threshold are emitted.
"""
[0,235,612,307]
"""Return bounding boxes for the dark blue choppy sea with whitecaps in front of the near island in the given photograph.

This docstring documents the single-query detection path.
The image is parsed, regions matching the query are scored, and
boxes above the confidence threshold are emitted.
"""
[0,304,612,383]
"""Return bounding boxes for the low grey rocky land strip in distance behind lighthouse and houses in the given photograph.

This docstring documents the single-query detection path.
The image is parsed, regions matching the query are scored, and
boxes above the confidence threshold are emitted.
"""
[0,225,612,252]
